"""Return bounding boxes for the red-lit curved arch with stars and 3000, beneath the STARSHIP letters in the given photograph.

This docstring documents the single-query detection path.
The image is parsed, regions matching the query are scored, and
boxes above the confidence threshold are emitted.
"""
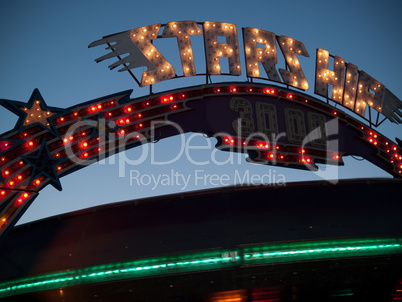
[0,83,402,236]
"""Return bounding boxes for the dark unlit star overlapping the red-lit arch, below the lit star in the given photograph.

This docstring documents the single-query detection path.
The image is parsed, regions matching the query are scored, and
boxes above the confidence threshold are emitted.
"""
[21,138,68,191]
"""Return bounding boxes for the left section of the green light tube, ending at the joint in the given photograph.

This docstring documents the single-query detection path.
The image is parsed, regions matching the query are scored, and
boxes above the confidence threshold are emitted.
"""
[0,250,240,297]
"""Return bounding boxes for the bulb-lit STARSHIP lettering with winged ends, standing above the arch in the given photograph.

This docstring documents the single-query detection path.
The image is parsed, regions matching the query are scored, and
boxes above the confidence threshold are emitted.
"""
[89,21,402,125]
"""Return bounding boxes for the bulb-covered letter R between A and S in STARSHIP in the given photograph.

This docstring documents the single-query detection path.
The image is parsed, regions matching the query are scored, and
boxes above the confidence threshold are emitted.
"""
[243,27,281,82]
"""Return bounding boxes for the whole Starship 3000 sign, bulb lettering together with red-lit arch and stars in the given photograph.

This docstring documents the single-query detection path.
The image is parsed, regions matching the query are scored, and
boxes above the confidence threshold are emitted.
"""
[0,21,402,239]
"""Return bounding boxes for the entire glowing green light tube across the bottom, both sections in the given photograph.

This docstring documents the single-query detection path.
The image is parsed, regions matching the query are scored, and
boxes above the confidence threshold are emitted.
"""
[0,238,402,298]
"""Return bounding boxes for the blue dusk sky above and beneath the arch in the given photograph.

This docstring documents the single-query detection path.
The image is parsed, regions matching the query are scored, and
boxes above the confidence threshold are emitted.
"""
[0,0,402,222]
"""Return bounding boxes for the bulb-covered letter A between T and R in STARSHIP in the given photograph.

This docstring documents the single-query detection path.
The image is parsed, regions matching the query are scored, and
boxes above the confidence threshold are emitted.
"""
[203,22,241,75]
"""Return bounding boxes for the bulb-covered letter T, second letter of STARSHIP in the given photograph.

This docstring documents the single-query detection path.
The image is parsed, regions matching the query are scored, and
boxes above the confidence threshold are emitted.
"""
[162,21,202,77]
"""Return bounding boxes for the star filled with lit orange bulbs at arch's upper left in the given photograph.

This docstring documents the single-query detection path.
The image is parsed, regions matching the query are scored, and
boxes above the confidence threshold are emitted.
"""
[0,89,66,137]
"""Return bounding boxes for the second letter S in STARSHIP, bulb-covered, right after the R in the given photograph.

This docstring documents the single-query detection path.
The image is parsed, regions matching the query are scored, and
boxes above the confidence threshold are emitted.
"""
[277,36,310,90]
